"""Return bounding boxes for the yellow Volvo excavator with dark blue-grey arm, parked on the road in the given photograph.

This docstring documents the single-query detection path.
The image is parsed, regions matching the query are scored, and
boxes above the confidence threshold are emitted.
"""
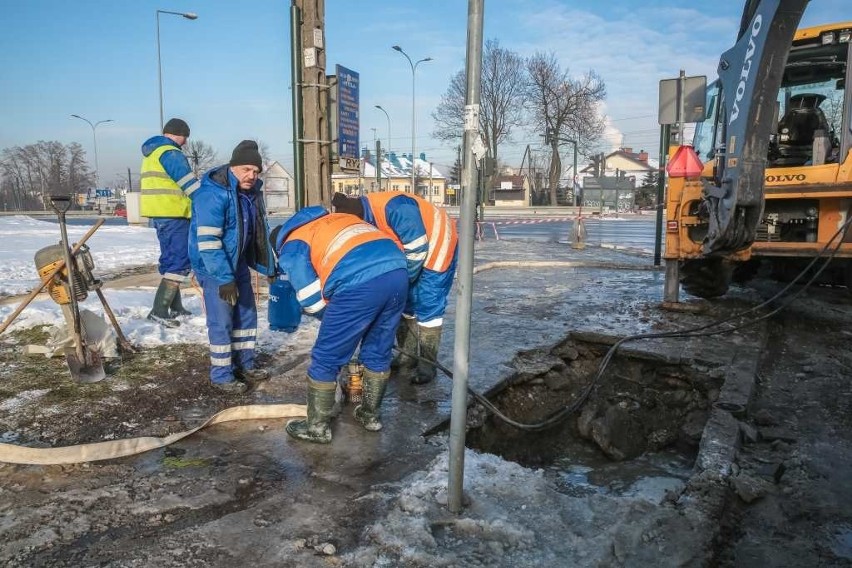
[665,0,852,299]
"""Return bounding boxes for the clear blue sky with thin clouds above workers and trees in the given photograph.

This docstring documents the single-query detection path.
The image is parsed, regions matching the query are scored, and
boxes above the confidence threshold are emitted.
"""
[0,0,852,184]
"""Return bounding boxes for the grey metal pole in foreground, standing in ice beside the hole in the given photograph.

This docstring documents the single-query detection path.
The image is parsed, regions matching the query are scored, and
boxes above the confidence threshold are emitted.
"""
[447,0,485,513]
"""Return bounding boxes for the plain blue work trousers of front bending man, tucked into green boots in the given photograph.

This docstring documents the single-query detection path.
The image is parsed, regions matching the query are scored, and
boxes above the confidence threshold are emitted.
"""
[308,268,408,382]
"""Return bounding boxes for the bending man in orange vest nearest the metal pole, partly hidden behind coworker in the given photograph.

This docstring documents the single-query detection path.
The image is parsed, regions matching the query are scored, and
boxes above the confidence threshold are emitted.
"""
[331,191,458,384]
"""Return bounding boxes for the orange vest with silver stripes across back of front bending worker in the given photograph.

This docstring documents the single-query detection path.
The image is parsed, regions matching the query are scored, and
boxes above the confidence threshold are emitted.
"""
[285,213,387,288]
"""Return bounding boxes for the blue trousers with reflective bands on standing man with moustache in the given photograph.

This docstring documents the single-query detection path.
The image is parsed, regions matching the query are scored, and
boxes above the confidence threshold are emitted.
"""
[198,261,257,383]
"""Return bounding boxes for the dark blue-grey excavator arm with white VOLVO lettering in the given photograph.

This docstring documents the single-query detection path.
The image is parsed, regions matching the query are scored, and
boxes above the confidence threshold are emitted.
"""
[702,0,808,256]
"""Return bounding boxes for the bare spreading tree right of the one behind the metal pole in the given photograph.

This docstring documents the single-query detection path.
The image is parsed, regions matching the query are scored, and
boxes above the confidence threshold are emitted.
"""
[527,53,606,205]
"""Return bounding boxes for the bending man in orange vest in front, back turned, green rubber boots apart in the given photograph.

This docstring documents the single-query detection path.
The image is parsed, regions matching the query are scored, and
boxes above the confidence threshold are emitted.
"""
[270,206,408,444]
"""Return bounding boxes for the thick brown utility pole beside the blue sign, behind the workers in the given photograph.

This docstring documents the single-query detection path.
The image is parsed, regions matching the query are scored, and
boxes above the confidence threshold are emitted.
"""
[291,0,331,207]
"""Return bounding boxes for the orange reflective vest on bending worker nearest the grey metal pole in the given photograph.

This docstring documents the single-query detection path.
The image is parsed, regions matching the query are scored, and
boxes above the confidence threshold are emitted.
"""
[366,191,459,272]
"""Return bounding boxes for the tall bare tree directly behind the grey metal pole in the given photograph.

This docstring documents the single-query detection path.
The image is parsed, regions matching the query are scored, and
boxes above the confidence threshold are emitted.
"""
[432,39,526,163]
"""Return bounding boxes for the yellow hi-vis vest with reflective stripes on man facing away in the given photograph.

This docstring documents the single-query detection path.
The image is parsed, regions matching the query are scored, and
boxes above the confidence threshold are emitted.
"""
[139,144,191,219]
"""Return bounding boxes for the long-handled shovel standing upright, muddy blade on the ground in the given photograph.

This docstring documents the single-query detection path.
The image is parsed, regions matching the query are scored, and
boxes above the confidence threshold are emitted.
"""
[50,195,106,383]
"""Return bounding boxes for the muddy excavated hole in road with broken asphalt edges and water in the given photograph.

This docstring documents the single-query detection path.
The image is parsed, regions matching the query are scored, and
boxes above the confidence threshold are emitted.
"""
[466,334,724,501]
